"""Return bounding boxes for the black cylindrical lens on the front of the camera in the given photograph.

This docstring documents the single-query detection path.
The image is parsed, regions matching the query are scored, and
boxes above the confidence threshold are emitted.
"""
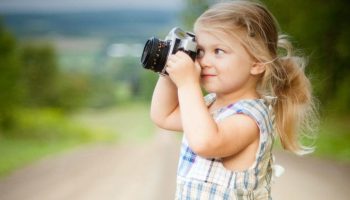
[141,37,169,72]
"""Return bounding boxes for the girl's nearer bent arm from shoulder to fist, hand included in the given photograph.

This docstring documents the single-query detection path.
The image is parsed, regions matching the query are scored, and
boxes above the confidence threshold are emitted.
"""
[168,52,259,157]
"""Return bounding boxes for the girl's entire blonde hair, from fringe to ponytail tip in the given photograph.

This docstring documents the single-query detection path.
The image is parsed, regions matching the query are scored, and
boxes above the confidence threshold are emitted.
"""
[194,0,318,154]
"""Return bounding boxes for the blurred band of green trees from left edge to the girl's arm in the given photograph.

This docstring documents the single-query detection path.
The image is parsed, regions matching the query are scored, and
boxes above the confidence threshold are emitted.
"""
[0,19,157,133]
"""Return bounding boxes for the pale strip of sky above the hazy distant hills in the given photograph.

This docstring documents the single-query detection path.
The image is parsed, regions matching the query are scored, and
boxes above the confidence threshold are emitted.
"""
[0,0,184,12]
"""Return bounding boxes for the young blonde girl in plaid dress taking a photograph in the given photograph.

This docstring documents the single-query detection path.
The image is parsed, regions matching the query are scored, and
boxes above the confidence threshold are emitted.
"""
[151,0,315,199]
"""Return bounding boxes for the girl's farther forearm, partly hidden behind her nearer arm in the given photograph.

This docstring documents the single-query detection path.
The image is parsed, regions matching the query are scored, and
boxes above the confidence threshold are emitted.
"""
[151,76,182,131]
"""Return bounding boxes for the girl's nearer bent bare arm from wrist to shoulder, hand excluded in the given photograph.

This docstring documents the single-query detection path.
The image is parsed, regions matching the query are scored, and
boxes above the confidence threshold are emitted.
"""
[178,84,259,158]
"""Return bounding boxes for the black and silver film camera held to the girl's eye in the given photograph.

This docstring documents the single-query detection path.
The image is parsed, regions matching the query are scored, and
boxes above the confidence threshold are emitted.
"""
[141,27,197,75]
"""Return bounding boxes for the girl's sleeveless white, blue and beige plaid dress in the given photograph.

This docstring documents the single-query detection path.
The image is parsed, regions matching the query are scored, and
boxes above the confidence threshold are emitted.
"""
[176,94,274,200]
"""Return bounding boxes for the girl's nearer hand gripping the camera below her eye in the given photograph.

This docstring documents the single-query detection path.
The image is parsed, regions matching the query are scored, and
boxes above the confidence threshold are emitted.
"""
[166,51,201,88]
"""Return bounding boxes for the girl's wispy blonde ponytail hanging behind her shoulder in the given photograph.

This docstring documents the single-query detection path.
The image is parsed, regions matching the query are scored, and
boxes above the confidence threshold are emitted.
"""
[270,35,317,154]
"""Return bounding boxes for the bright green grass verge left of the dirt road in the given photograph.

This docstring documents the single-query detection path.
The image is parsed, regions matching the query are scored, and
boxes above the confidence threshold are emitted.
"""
[0,109,118,177]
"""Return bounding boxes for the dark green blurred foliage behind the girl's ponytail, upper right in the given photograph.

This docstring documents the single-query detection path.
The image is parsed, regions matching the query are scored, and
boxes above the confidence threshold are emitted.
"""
[264,0,350,114]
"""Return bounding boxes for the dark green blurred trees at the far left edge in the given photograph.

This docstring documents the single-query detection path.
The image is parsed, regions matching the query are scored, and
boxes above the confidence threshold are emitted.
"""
[0,21,87,129]
